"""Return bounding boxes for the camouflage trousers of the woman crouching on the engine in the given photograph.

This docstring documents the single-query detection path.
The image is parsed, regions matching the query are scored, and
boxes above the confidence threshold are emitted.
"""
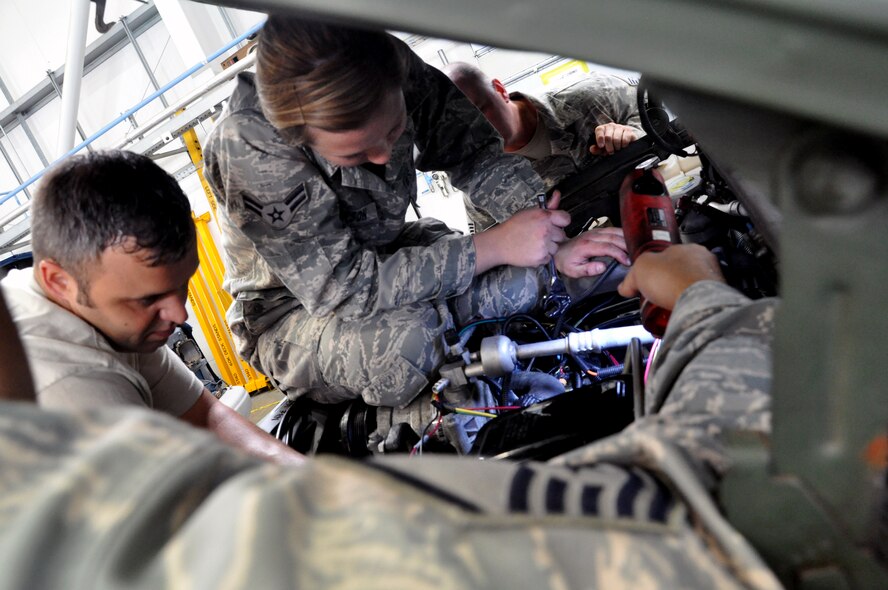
[257,267,546,407]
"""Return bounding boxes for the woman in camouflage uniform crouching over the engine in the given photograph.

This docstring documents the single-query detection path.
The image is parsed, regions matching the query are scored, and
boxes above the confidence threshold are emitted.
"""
[205,15,569,414]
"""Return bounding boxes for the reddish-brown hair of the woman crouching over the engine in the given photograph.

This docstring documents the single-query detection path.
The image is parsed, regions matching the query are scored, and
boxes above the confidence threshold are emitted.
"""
[256,14,409,144]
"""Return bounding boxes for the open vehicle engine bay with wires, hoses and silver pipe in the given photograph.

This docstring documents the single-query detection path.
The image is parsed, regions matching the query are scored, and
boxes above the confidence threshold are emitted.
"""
[260,80,778,460]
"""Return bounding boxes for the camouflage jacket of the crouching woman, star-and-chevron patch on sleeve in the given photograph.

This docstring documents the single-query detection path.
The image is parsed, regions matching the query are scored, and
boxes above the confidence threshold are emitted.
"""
[204,39,542,358]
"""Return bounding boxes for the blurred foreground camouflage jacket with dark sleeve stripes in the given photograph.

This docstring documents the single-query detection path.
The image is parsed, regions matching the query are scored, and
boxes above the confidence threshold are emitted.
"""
[0,283,779,590]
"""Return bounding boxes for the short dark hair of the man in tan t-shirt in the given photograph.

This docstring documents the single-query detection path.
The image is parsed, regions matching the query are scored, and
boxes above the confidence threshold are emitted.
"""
[31,150,196,286]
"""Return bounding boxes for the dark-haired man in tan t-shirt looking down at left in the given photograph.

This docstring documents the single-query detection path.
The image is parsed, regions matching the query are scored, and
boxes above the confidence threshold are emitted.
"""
[2,151,302,470]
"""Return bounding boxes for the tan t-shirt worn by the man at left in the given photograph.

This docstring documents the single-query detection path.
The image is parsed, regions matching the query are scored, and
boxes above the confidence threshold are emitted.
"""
[0,269,203,416]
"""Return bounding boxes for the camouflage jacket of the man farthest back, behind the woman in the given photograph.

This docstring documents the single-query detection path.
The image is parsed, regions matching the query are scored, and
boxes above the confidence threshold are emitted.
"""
[511,73,644,190]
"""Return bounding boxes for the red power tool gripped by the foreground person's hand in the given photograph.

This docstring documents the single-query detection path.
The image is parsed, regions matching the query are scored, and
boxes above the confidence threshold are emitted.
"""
[620,160,681,338]
